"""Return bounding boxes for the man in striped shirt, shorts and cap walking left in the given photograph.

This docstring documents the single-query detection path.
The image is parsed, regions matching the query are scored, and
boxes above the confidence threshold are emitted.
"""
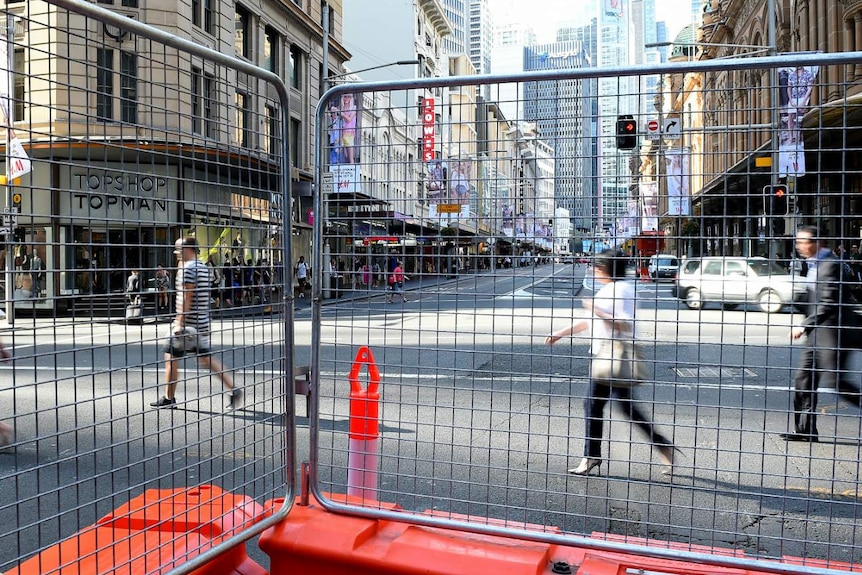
[150,236,243,409]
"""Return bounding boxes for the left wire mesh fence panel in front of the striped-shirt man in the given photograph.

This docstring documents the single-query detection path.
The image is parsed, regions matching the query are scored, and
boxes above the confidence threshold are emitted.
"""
[0,2,293,573]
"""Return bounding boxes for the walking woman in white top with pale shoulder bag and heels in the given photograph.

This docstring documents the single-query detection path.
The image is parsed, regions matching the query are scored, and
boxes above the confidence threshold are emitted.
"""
[545,250,676,475]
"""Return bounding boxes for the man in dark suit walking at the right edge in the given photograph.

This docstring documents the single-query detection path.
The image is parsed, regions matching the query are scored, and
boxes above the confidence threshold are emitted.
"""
[781,226,862,442]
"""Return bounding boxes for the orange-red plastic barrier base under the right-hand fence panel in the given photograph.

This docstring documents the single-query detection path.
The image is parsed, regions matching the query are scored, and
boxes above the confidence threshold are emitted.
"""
[260,501,851,575]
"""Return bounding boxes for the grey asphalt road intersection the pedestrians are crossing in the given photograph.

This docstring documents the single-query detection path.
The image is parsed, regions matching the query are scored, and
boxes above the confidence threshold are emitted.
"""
[0,265,862,571]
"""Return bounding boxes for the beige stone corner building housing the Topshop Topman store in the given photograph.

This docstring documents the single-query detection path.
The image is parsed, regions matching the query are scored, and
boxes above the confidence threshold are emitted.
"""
[9,0,349,309]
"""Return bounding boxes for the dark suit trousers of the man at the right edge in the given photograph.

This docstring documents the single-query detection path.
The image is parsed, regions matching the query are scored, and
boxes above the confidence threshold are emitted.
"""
[793,327,862,435]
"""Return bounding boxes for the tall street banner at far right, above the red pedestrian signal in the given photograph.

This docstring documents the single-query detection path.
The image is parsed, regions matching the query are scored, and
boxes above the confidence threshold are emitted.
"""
[778,66,818,177]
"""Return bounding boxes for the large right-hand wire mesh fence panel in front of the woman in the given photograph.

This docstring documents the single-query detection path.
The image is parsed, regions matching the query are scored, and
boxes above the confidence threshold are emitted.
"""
[311,54,862,569]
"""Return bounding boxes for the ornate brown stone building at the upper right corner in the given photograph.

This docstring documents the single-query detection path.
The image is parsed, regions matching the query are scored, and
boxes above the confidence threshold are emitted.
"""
[664,0,862,257]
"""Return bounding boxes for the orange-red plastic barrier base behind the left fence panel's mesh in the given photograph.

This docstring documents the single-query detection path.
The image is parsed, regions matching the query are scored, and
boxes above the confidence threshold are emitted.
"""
[6,485,267,575]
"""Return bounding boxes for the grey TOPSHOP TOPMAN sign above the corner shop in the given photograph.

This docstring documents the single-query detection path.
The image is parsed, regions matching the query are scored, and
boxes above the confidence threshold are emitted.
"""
[60,164,178,224]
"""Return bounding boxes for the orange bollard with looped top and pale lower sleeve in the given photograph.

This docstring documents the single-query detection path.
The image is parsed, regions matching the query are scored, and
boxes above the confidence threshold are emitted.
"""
[347,346,380,499]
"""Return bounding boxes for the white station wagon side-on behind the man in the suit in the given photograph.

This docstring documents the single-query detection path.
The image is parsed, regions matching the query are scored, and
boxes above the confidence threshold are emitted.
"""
[674,256,806,313]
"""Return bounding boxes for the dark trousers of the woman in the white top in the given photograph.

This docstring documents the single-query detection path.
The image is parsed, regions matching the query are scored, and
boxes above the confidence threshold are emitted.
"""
[584,380,673,459]
